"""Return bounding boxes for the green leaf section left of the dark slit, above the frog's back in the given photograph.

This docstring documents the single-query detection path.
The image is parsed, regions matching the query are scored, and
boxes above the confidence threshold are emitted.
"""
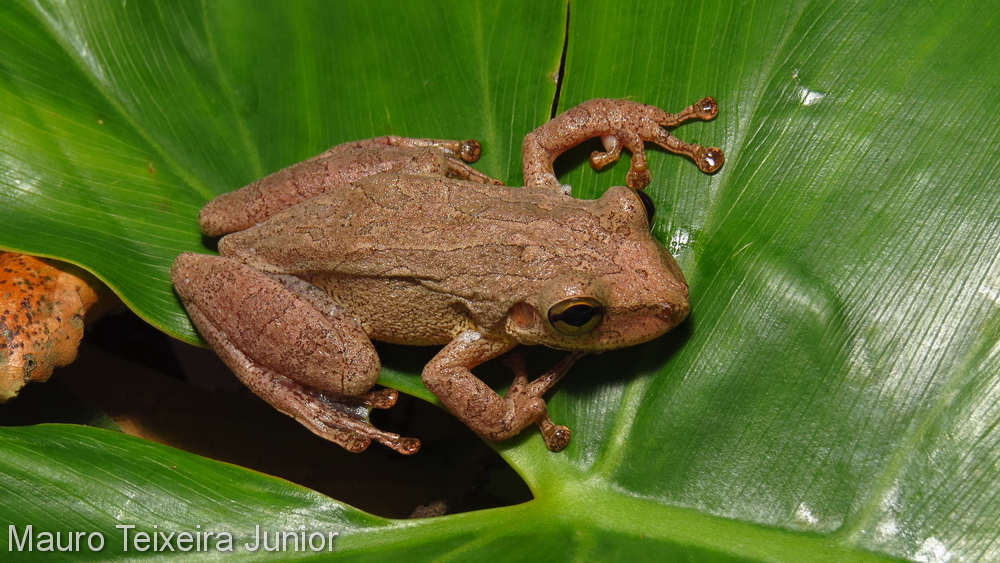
[0,2,565,341]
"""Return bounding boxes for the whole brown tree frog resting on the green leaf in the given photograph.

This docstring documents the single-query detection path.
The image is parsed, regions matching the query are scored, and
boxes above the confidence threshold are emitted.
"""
[170,97,724,454]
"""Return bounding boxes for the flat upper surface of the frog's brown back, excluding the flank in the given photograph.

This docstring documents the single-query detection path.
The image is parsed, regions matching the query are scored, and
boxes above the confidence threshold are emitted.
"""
[220,174,611,284]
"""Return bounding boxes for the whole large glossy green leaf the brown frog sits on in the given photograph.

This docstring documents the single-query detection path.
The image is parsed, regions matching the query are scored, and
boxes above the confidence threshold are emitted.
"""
[0,0,1000,561]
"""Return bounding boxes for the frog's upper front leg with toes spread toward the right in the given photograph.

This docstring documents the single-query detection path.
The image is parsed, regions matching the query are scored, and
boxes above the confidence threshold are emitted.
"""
[521,98,725,191]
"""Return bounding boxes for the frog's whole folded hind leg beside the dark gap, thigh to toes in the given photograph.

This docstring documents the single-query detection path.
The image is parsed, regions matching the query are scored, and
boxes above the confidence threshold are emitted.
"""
[171,253,420,454]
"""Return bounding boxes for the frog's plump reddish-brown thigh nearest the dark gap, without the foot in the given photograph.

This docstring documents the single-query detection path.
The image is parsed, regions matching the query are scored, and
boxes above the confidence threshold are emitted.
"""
[171,254,380,398]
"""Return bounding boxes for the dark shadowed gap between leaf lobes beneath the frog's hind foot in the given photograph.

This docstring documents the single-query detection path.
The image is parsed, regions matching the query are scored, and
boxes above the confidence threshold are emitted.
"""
[0,312,532,518]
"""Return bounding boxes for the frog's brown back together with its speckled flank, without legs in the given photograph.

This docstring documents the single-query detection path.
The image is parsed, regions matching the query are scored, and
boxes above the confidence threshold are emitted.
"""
[219,174,659,344]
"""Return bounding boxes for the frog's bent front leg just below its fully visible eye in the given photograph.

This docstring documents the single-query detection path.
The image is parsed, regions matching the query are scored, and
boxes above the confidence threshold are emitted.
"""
[423,330,584,451]
